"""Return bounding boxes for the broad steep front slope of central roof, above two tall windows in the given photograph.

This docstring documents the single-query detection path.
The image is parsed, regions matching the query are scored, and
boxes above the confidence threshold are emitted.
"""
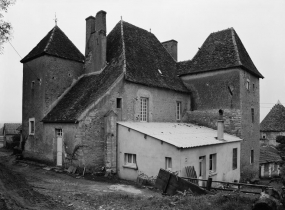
[123,22,189,92]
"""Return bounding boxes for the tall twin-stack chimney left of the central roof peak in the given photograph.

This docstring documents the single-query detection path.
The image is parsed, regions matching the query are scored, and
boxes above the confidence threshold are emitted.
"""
[84,10,107,73]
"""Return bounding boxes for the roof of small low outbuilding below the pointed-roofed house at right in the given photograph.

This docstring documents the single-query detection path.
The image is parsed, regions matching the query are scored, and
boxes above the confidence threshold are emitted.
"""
[259,146,282,164]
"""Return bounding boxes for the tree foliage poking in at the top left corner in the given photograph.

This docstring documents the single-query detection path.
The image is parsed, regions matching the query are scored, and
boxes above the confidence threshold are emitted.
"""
[0,0,16,54]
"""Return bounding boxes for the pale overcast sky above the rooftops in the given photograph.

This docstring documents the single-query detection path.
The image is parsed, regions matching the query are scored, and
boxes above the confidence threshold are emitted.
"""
[0,0,285,123]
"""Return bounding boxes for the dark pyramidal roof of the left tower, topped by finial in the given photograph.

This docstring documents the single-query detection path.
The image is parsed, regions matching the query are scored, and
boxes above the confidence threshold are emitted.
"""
[21,26,84,63]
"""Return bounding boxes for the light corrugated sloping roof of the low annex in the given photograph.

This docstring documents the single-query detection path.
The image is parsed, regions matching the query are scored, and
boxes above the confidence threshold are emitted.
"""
[118,122,242,148]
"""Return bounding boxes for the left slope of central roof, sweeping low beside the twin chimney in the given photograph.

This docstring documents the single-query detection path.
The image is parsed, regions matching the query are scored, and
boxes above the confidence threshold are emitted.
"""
[42,24,123,123]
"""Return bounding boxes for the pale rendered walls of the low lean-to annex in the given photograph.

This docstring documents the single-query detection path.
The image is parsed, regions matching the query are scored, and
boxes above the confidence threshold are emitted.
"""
[118,125,240,181]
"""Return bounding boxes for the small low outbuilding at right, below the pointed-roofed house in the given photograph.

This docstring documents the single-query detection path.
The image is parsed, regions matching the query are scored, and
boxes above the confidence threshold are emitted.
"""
[259,146,282,178]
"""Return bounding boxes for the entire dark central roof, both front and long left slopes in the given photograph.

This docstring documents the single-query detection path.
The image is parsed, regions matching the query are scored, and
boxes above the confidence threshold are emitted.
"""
[42,22,188,122]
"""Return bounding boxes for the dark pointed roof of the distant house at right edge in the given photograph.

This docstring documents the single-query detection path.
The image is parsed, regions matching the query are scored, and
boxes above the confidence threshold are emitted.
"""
[260,103,285,132]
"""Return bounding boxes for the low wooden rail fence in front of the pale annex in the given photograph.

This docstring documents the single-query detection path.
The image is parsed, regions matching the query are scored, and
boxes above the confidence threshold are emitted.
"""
[181,177,270,194]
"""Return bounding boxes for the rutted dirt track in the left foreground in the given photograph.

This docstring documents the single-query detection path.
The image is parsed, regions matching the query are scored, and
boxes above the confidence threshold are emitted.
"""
[0,149,159,210]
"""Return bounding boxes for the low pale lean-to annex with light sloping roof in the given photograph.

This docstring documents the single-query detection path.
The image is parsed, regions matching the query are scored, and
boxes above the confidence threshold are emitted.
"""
[117,121,242,185]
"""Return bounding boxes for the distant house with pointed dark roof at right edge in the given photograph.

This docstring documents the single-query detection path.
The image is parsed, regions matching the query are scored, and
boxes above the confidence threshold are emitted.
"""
[260,101,285,146]
